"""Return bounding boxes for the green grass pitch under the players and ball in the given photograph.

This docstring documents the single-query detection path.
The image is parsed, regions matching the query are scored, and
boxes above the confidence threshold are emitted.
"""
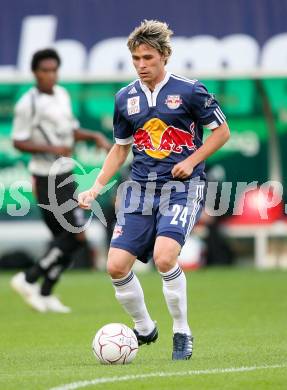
[0,268,287,390]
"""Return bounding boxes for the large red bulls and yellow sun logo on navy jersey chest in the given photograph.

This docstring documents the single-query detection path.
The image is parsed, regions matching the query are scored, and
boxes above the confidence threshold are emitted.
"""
[134,118,196,159]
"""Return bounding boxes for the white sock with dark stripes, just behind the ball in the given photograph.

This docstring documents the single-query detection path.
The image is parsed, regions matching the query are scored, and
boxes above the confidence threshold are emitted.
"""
[112,271,154,336]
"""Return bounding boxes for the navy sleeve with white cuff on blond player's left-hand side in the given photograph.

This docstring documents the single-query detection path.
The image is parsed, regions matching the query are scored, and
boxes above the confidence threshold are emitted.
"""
[113,96,134,145]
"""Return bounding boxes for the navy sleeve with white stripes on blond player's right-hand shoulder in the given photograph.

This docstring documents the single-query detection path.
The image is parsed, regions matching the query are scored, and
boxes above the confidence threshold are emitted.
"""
[191,82,226,130]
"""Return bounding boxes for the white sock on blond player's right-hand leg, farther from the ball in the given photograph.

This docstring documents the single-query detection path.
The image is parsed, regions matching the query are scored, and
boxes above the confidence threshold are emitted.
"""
[160,264,191,335]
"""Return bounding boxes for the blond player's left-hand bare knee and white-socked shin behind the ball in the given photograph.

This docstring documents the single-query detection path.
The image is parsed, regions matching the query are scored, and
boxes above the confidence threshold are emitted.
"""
[107,248,155,335]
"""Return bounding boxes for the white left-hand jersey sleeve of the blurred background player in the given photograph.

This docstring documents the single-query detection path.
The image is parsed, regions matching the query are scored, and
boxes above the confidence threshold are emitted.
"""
[12,99,32,141]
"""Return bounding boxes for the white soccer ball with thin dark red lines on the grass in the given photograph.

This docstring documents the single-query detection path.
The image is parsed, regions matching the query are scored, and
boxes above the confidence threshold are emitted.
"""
[92,323,138,364]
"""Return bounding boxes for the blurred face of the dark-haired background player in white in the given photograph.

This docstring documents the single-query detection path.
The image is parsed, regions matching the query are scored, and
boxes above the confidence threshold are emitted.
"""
[34,58,59,93]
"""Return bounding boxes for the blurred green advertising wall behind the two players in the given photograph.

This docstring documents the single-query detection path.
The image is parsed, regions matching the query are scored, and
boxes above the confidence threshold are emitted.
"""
[0,78,287,219]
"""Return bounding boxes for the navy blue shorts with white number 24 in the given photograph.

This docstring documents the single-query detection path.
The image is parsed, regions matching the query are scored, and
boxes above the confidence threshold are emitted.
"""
[110,178,205,263]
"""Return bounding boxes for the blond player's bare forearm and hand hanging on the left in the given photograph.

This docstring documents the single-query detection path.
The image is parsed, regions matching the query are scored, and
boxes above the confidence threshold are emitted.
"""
[78,144,131,210]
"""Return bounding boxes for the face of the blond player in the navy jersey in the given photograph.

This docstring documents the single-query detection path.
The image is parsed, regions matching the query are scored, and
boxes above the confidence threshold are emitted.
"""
[132,44,166,90]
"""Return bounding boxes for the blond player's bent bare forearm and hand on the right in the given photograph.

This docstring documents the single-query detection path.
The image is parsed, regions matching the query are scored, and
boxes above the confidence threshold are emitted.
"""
[171,122,230,179]
